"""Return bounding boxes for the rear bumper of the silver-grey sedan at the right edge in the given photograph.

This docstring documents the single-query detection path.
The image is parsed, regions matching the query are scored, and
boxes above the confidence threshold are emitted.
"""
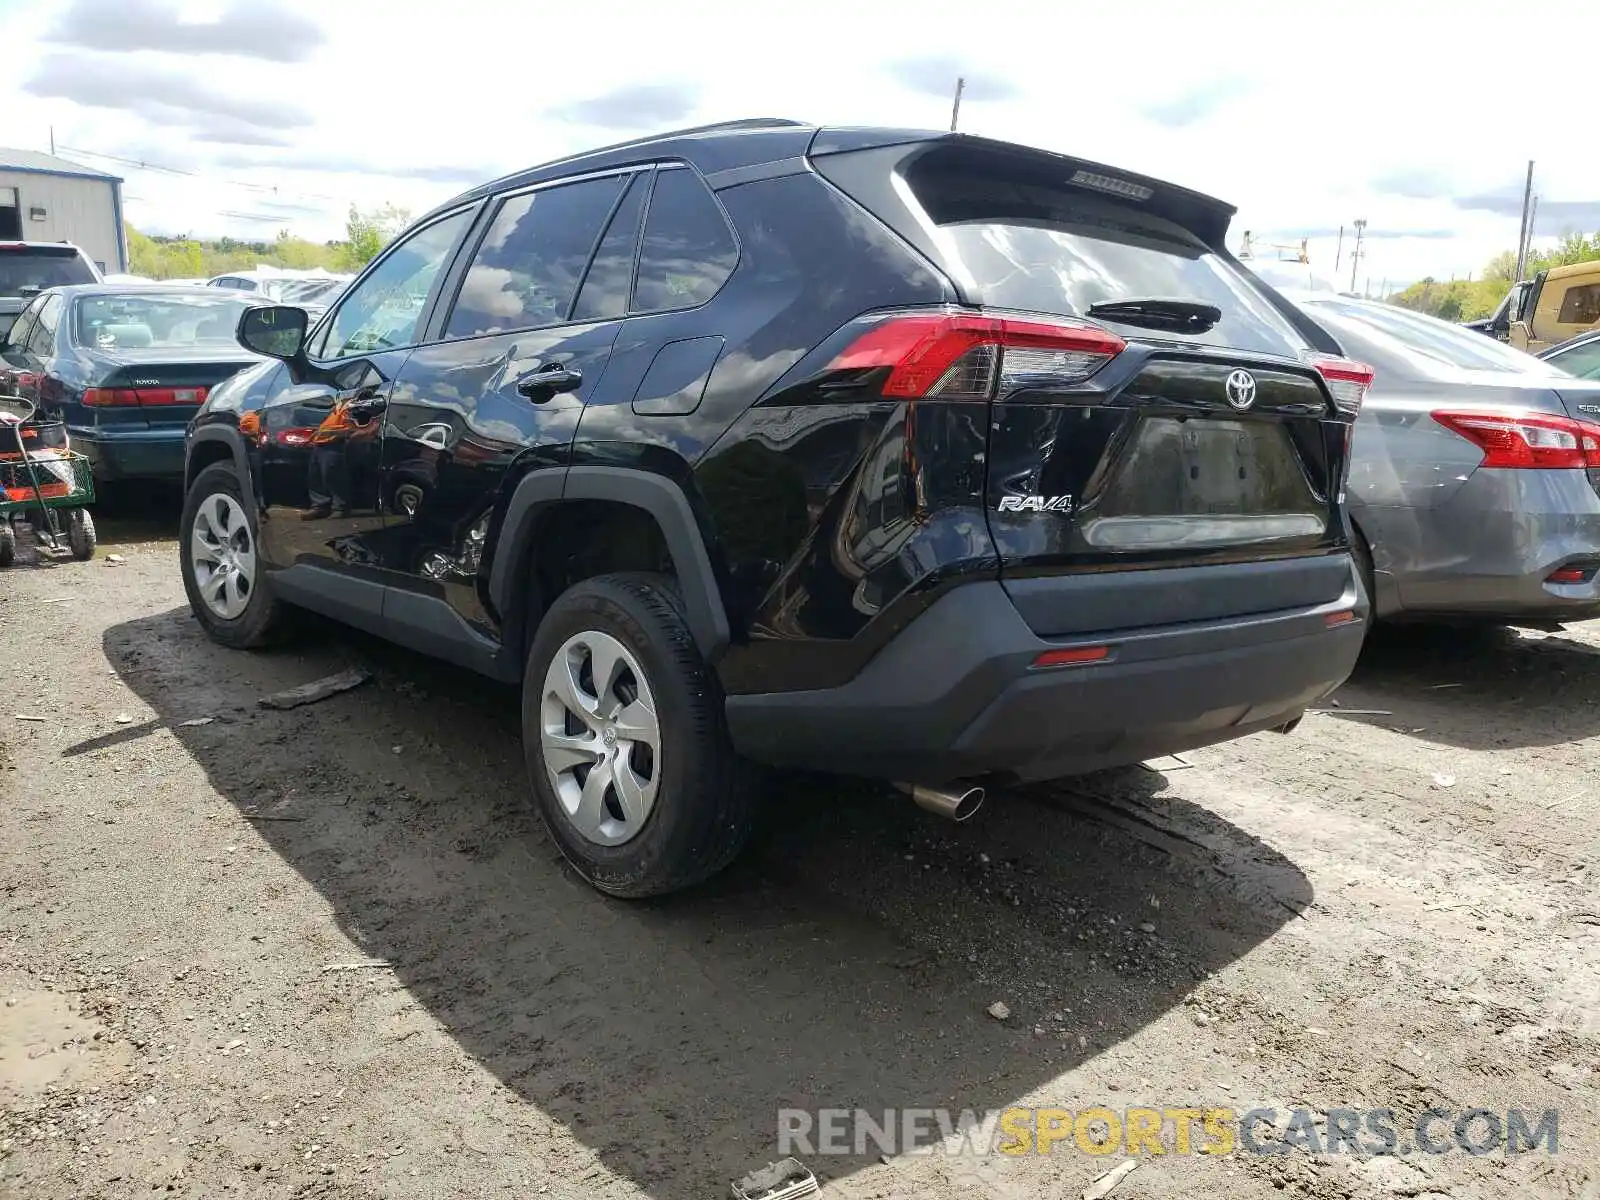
[1355,470,1600,621]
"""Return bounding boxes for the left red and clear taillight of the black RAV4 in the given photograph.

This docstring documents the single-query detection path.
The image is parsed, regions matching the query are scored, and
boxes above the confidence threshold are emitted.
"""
[829,314,1128,400]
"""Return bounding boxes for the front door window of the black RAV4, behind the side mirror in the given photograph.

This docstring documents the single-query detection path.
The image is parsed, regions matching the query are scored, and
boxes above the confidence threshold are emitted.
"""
[314,210,472,358]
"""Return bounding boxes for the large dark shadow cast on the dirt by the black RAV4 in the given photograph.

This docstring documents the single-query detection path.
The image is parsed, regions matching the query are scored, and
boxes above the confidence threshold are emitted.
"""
[104,611,1312,1200]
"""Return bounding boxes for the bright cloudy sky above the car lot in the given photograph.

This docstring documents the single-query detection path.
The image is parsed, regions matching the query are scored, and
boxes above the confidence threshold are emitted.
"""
[0,0,1600,288]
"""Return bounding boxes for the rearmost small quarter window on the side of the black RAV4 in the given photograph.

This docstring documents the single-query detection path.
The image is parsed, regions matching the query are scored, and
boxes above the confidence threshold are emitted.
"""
[634,170,739,320]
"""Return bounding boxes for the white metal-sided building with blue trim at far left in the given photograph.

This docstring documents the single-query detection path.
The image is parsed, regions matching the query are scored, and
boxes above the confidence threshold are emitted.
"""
[0,147,128,274]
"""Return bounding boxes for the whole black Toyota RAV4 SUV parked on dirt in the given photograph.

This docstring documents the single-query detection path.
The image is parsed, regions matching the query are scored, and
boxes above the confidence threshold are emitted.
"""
[181,120,1371,896]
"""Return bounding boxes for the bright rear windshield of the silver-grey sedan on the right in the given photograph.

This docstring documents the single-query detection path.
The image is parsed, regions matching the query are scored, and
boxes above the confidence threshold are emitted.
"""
[1306,299,1554,379]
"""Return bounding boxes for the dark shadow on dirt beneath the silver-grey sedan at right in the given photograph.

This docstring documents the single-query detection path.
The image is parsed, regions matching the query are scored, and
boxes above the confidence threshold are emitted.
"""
[1328,624,1600,749]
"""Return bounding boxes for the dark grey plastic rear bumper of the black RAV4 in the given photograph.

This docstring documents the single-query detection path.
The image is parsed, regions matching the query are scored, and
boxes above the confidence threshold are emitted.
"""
[728,566,1366,784]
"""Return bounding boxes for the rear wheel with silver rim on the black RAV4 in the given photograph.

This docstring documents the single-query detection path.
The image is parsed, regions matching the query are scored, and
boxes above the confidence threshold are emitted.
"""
[522,573,757,899]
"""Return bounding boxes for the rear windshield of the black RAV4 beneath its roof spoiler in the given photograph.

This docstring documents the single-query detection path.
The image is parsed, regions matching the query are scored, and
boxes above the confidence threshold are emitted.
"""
[912,171,1306,357]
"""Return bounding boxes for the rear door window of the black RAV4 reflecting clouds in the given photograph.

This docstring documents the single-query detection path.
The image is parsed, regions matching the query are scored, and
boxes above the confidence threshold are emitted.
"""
[445,176,626,338]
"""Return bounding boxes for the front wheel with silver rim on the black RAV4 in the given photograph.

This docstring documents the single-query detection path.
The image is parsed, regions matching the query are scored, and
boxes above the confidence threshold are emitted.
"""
[178,462,286,650]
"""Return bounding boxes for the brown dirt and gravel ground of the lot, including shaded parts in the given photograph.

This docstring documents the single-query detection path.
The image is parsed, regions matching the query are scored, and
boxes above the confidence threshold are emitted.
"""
[0,501,1600,1200]
